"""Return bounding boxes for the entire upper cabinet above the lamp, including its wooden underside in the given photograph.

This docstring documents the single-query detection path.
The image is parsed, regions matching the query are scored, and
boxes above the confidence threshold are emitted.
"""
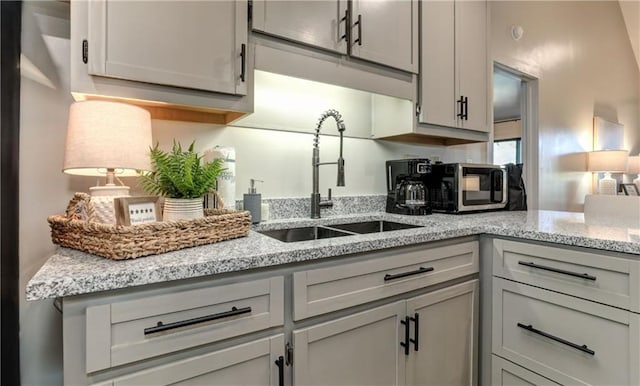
[70,0,250,124]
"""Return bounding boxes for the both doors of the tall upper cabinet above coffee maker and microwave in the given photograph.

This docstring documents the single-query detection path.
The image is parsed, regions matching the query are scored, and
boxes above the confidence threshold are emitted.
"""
[419,0,490,132]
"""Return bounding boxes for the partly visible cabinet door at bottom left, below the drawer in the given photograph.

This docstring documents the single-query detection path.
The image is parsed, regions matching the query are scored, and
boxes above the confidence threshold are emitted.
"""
[101,334,284,386]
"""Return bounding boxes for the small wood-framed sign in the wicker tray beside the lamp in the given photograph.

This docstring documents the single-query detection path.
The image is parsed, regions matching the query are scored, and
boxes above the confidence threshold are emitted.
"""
[113,196,162,225]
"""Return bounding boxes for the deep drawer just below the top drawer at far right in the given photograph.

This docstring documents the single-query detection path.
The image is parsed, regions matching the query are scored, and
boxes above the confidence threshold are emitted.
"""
[492,279,640,385]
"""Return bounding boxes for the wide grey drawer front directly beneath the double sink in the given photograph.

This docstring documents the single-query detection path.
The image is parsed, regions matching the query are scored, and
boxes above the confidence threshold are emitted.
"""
[293,241,478,320]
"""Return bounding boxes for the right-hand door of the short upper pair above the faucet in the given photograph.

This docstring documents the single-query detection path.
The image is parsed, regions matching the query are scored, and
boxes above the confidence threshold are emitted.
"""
[351,0,418,73]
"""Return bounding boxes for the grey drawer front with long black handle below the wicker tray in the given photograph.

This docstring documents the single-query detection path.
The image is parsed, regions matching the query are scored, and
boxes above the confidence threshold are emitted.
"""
[86,277,284,373]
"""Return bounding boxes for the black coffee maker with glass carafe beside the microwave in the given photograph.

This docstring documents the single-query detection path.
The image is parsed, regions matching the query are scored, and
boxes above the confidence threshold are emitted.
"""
[386,158,431,215]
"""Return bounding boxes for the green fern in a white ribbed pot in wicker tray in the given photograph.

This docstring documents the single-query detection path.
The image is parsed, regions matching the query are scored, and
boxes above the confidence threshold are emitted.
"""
[142,140,224,221]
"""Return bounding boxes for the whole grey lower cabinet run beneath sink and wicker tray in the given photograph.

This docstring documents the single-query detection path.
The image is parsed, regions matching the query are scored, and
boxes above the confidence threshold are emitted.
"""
[62,238,478,386]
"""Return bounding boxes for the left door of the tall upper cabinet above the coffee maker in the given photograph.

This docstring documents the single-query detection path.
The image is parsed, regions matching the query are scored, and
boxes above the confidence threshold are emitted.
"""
[419,0,458,127]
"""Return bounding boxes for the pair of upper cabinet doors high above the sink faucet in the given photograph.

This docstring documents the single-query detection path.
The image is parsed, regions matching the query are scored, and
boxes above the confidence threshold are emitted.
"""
[253,0,418,73]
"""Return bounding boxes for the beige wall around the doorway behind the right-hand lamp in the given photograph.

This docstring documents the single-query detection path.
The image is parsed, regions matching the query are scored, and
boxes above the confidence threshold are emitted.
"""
[491,1,640,211]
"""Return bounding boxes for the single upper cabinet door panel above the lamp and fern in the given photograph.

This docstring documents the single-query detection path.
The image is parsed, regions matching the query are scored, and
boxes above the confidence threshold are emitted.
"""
[88,0,248,95]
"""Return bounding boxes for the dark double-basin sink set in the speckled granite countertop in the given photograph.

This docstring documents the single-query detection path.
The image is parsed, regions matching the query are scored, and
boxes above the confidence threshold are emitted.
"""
[259,220,421,243]
